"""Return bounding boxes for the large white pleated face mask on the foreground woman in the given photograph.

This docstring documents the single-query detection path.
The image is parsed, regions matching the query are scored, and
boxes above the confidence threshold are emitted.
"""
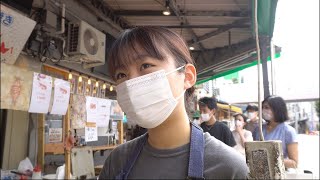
[116,66,185,129]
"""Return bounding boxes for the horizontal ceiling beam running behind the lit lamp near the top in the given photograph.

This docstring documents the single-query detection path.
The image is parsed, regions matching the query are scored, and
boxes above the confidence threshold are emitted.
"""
[114,10,251,17]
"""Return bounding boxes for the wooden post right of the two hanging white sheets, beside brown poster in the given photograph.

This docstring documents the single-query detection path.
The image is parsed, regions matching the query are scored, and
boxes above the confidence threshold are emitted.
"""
[64,104,72,179]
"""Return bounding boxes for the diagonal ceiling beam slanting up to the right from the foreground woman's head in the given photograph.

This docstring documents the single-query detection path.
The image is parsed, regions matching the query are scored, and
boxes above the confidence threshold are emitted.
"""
[188,18,249,45]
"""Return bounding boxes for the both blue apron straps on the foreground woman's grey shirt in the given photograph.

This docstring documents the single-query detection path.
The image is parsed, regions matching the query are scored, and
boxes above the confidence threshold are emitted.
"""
[116,124,204,179]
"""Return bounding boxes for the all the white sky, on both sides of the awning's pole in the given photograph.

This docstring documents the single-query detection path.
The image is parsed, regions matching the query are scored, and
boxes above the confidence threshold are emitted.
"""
[217,0,319,103]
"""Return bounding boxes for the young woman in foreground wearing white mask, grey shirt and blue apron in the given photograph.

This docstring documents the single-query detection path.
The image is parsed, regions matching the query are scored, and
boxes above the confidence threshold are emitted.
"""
[99,27,247,179]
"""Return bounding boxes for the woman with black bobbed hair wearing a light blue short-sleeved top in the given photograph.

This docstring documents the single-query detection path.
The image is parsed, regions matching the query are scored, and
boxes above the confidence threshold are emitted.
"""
[253,96,298,168]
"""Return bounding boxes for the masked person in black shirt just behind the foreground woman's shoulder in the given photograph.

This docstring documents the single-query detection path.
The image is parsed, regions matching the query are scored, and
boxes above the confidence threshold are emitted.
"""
[198,97,236,147]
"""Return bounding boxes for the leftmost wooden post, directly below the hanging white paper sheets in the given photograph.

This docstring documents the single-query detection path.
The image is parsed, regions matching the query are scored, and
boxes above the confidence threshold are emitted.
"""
[37,114,45,170]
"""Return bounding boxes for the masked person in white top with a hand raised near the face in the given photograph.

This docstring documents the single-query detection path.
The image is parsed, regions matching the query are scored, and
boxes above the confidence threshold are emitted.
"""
[232,114,253,156]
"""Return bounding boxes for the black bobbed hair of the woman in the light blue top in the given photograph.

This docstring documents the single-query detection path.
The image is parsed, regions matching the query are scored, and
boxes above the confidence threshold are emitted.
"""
[262,96,289,122]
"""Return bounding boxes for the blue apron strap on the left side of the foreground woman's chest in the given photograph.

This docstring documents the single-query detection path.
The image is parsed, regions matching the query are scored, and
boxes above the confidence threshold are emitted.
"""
[116,133,148,179]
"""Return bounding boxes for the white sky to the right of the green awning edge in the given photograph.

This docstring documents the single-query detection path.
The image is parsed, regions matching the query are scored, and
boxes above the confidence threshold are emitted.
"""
[273,0,319,97]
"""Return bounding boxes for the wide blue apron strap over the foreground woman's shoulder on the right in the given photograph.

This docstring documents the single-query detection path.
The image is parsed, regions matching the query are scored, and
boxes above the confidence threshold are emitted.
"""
[187,123,204,179]
